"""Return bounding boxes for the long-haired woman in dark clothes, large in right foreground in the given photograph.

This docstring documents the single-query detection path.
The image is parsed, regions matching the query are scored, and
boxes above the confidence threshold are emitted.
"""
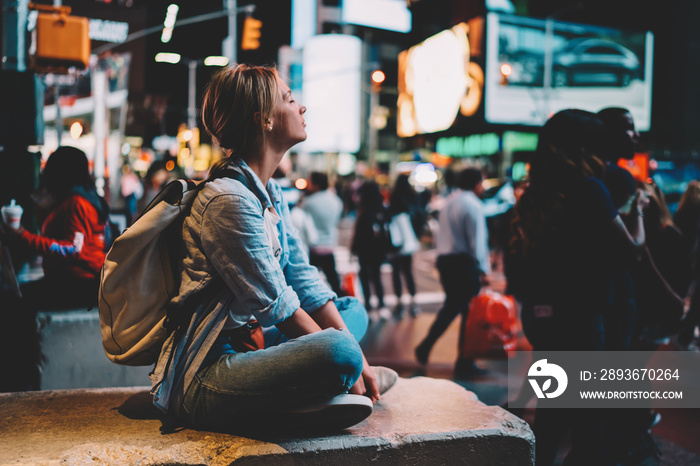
[512,109,645,466]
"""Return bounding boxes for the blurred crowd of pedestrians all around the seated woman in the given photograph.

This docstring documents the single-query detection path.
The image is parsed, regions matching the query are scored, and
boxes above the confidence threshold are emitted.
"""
[0,103,700,465]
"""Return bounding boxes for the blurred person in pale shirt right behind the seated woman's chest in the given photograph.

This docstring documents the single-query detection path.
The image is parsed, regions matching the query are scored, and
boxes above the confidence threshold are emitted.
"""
[303,172,343,296]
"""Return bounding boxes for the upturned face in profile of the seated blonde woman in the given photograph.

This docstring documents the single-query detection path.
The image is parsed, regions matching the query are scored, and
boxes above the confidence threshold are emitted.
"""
[268,78,306,149]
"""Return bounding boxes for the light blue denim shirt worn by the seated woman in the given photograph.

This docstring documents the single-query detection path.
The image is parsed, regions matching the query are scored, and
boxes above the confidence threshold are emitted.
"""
[151,161,337,412]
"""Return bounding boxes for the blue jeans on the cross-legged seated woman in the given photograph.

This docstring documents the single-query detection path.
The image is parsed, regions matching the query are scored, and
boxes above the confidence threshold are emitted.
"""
[181,298,368,428]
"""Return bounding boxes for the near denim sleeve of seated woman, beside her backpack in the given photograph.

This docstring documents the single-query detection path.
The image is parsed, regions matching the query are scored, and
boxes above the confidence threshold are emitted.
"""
[200,193,300,327]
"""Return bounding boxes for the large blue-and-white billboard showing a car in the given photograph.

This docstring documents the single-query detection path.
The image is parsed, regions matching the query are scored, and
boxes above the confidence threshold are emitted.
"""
[484,13,653,131]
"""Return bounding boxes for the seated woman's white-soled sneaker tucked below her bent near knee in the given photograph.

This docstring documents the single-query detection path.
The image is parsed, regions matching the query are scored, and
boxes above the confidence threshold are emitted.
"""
[281,394,372,430]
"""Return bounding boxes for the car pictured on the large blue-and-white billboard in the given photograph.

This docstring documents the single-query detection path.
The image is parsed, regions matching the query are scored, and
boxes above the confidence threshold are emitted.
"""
[501,38,640,87]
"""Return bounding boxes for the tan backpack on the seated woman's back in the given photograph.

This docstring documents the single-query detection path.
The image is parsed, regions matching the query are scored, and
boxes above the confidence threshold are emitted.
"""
[98,169,251,366]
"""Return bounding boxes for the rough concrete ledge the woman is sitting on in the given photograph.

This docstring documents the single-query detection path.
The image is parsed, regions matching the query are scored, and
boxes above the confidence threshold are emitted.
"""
[0,377,534,465]
